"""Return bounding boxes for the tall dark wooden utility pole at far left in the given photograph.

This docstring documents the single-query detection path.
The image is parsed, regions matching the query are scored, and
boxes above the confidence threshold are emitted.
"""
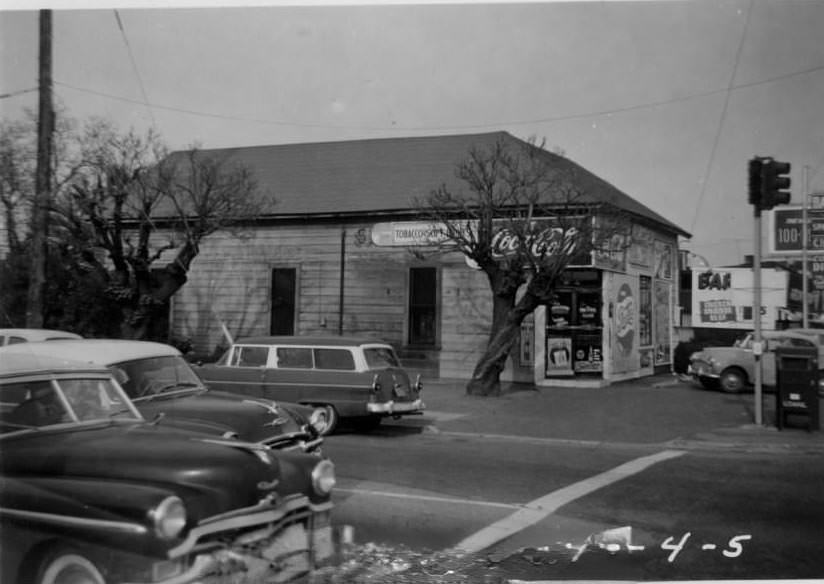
[26,10,54,328]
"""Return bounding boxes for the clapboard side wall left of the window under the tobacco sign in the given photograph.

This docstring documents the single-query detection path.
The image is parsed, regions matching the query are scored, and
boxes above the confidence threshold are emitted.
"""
[173,224,424,352]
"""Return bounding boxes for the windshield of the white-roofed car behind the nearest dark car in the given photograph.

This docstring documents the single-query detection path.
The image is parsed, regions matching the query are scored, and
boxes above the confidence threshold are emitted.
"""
[111,355,203,399]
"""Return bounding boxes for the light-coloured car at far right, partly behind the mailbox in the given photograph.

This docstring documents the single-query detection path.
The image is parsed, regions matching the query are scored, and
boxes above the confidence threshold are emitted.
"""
[689,329,824,393]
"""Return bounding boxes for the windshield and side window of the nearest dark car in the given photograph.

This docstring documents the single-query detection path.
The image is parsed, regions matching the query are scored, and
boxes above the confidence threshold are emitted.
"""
[0,378,142,433]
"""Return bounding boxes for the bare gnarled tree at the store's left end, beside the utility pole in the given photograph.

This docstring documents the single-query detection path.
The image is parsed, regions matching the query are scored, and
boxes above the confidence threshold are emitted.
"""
[60,120,263,339]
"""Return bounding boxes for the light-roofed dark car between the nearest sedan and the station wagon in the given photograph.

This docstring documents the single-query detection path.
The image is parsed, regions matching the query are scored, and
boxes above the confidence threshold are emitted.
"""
[0,339,326,451]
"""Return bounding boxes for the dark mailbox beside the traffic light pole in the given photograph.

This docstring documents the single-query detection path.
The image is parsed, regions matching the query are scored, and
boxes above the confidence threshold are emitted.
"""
[775,347,821,430]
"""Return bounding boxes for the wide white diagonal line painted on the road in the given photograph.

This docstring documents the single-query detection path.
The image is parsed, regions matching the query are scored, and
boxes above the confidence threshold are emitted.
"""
[453,450,686,553]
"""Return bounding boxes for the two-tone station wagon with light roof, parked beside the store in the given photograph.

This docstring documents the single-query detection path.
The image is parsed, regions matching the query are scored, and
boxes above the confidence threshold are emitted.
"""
[198,336,426,433]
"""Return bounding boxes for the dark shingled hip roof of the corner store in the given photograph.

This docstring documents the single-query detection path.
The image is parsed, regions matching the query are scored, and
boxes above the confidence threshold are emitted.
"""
[170,132,690,237]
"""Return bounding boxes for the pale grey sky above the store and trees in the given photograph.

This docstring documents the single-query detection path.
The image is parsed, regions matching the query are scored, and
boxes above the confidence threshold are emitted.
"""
[0,0,824,266]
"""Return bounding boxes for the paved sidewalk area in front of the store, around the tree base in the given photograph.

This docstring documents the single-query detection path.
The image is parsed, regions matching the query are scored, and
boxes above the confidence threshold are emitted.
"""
[403,373,824,453]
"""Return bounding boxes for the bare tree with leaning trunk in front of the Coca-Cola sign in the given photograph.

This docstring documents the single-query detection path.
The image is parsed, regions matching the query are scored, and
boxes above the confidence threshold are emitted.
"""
[417,139,630,395]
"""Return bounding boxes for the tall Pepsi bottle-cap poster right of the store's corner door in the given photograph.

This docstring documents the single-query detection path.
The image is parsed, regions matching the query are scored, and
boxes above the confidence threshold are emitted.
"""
[609,274,639,373]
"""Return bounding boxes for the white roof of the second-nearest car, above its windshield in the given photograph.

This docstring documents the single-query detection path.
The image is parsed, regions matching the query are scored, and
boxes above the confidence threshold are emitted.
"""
[0,339,181,365]
